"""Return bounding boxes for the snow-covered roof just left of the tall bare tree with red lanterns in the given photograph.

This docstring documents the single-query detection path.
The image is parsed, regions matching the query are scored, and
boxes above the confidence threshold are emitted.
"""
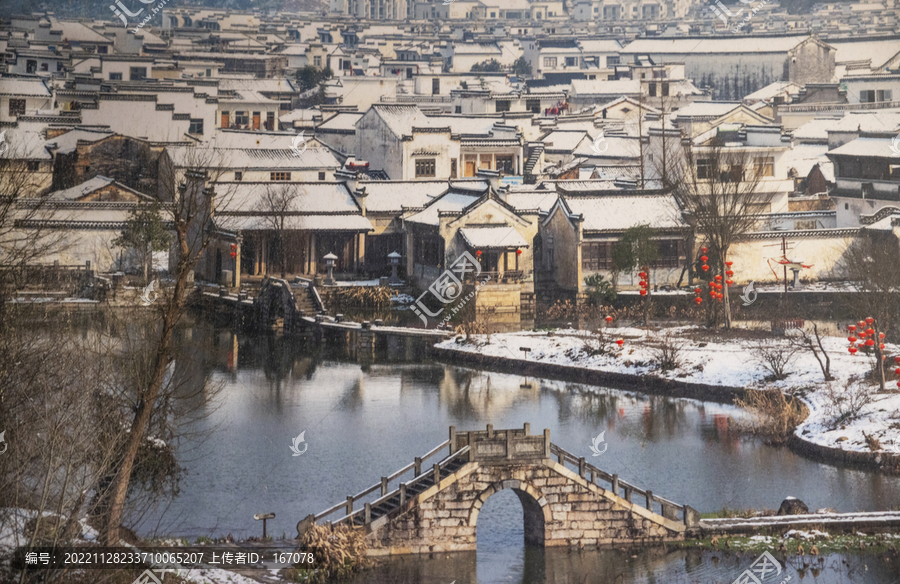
[565,195,684,231]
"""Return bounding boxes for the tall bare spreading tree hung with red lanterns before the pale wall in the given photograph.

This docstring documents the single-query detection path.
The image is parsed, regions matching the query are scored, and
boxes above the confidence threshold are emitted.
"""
[666,137,771,328]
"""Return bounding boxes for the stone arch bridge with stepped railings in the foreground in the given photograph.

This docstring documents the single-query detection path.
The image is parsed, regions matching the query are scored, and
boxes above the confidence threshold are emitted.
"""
[297,424,700,555]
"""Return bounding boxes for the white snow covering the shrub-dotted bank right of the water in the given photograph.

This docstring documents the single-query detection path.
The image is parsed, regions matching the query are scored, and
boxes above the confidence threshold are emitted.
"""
[436,326,900,453]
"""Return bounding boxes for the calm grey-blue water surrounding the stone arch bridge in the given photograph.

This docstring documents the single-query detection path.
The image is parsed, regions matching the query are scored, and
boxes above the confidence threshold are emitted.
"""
[148,325,900,584]
